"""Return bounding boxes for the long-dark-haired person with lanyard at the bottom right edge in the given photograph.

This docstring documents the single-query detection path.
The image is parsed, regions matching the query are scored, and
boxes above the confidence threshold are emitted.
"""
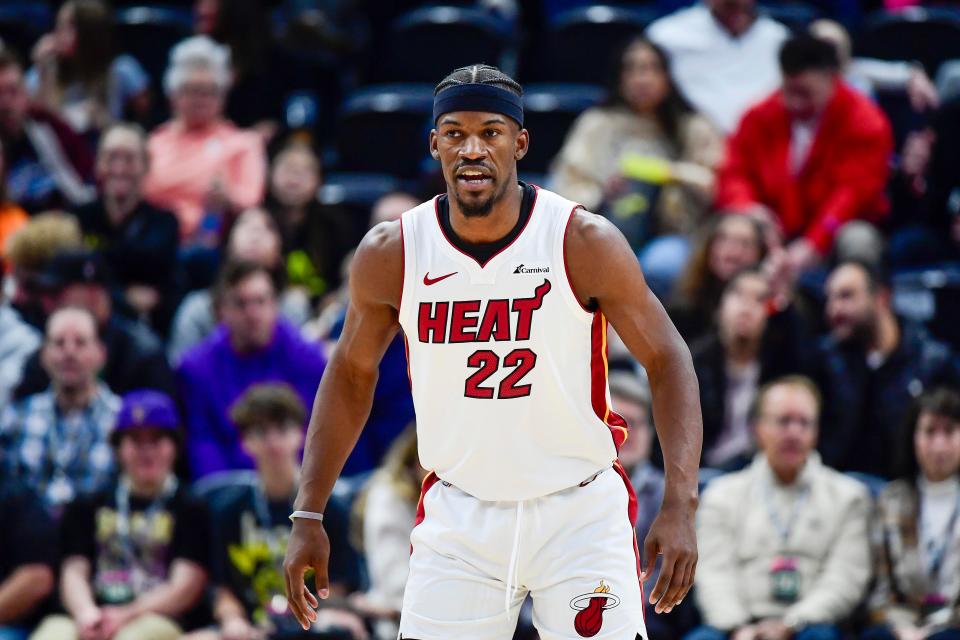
[863,388,960,640]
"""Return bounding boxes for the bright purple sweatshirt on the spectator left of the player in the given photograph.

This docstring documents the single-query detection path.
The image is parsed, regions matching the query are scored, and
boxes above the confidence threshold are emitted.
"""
[177,318,326,479]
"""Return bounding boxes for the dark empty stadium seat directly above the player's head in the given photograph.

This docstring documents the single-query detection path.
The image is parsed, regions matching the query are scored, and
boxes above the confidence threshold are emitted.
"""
[375,6,514,84]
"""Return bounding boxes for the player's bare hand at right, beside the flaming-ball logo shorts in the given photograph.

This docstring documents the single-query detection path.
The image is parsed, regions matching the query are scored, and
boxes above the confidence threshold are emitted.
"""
[641,504,697,613]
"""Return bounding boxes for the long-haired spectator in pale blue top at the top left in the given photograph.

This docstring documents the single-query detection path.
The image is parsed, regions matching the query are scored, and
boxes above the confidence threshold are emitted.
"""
[26,0,150,134]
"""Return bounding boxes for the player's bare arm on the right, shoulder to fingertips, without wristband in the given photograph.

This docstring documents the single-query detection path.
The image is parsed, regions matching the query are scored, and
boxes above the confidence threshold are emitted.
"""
[564,211,703,613]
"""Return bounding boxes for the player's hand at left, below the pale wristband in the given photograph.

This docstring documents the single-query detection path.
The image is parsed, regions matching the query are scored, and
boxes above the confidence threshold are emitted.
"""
[283,518,330,631]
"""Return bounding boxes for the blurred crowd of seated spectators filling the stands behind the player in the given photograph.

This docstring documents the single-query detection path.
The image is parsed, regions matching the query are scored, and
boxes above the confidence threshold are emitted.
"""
[0,0,960,640]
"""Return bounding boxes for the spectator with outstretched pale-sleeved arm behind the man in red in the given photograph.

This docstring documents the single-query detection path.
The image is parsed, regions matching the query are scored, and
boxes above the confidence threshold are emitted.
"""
[810,19,940,112]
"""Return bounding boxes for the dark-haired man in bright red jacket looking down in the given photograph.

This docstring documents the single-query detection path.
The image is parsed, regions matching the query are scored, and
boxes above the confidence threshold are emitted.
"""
[716,35,893,273]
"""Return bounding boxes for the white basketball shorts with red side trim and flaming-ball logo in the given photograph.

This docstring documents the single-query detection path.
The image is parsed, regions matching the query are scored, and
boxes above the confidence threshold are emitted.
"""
[400,462,647,640]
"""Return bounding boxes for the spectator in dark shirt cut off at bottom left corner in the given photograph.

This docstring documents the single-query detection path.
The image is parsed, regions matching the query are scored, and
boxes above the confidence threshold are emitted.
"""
[0,478,57,640]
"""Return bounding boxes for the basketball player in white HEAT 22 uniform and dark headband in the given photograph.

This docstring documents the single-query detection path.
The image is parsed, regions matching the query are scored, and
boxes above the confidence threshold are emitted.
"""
[285,65,702,640]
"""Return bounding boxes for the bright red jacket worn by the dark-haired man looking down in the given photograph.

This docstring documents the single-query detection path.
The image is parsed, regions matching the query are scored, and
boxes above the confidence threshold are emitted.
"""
[716,81,893,253]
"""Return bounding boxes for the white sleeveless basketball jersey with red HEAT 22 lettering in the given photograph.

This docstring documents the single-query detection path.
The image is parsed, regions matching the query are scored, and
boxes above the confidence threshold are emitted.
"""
[400,189,627,500]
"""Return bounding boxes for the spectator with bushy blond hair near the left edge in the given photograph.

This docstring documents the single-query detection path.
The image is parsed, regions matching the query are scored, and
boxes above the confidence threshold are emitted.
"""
[7,211,83,329]
